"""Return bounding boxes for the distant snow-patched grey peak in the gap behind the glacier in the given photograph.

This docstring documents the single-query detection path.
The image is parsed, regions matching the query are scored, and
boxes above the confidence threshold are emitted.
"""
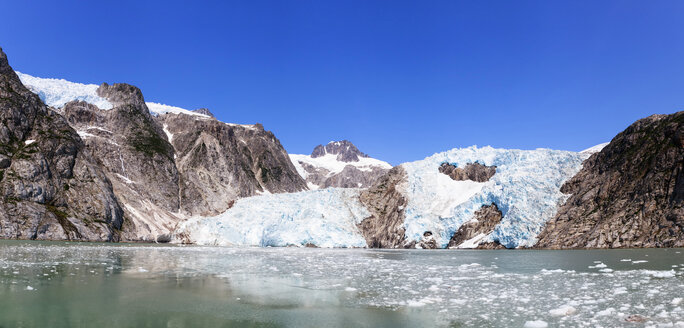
[290,140,392,189]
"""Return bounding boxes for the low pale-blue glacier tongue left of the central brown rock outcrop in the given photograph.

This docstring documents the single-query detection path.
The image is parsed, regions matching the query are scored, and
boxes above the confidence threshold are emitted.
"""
[179,188,370,247]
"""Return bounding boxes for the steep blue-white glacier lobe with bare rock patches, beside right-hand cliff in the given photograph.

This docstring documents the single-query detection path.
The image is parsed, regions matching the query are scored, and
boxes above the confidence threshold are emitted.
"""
[402,146,589,248]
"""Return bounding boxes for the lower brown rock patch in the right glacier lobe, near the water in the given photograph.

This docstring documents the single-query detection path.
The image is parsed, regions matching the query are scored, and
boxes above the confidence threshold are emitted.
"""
[448,203,503,248]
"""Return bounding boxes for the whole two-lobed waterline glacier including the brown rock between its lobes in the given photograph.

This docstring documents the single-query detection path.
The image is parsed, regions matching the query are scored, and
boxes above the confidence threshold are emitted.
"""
[178,147,589,248]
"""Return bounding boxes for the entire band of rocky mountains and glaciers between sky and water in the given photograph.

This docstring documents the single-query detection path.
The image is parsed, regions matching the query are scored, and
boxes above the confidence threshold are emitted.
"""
[0,50,684,248]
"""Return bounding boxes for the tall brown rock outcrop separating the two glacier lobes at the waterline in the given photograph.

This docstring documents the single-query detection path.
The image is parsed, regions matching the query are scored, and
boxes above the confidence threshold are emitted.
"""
[358,166,414,248]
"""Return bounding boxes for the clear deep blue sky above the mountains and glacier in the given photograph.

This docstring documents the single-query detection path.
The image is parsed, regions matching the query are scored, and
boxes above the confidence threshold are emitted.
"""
[0,0,684,164]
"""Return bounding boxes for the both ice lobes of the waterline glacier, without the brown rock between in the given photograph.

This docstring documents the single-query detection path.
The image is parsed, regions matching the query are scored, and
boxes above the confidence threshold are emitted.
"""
[177,146,589,248]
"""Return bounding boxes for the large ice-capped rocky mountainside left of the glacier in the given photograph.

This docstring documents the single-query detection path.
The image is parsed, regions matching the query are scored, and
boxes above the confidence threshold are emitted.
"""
[12,50,306,242]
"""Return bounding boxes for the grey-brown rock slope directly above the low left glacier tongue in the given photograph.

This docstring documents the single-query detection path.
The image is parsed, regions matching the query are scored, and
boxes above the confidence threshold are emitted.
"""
[157,113,307,216]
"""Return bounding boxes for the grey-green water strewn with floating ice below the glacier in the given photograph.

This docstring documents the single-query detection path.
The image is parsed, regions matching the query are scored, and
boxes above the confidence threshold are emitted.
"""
[0,241,684,327]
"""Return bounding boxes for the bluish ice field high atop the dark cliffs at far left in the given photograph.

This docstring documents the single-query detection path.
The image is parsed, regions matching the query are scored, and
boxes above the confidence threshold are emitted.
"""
[17,72,113,109]
